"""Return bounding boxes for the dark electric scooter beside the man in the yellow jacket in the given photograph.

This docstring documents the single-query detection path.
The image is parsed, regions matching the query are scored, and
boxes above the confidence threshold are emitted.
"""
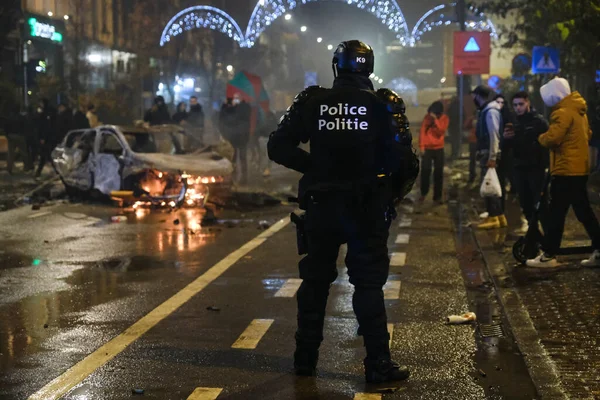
[513,172,594,265]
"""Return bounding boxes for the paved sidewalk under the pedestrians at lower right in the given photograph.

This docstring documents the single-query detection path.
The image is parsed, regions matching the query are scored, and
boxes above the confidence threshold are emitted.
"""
[452,158,600,399]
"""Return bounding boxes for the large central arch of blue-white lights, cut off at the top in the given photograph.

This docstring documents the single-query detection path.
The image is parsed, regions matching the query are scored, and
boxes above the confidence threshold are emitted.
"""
[242,0,410,47]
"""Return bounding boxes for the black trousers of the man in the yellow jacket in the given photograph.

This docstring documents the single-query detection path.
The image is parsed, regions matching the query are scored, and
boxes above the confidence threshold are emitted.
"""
[543,175,600,255]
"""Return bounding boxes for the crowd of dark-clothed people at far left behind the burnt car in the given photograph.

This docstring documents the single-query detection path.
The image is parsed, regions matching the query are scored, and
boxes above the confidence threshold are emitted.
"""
[0,99,102,178]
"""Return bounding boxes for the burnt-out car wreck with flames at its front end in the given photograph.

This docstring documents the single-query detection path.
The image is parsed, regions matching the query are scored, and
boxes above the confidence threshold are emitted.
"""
[52,125,233,207]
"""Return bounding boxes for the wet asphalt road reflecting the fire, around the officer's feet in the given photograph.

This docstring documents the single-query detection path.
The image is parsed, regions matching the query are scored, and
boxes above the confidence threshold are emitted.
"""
[0,179,536,400]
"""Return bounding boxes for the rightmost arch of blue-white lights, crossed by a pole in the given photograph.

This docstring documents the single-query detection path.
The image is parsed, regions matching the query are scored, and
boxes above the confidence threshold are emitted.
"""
[410,3,498,46]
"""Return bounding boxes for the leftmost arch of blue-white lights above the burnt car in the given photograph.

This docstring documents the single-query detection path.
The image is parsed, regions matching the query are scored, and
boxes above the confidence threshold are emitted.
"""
[160,6,245,46]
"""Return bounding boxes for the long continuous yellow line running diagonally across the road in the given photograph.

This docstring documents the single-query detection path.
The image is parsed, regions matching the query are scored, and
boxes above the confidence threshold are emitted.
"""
[29,218,290,400]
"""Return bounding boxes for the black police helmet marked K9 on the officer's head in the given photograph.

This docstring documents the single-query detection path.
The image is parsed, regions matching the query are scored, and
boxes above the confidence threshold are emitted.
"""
[332,40,375,76]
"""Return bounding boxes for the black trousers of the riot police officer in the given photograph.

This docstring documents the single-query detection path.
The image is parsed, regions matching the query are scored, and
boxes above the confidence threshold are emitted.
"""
[296,194,390,360]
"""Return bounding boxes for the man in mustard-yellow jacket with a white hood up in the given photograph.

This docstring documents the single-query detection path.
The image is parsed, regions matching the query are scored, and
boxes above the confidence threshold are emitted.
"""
[527,78,600,268]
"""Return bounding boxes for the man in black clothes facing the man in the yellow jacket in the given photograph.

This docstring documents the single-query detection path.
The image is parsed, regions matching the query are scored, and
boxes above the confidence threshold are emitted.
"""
[504,92,548,234]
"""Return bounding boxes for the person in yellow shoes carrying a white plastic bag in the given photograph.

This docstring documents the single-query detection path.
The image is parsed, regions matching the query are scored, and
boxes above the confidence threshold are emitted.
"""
[471,86,508,229]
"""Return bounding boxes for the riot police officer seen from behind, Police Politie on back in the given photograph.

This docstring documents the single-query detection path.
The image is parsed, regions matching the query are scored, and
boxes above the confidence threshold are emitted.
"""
[268,40,418,383]
